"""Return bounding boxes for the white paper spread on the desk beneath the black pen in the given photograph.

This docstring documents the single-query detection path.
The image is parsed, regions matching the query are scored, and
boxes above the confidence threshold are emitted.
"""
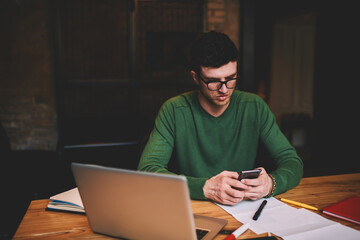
[217,197,360,240]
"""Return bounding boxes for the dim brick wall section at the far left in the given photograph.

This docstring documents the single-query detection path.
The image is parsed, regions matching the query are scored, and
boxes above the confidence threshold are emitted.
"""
[0,0,57,150]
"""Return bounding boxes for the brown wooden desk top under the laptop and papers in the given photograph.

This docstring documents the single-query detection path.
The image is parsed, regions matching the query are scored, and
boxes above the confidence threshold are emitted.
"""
[13,173,360,239]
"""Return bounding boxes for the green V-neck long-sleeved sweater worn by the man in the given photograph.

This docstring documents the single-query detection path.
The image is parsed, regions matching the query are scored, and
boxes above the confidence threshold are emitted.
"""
[138,90,303,199]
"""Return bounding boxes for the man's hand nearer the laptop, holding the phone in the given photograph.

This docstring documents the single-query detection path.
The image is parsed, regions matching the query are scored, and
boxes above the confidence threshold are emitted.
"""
[203,171,250,205]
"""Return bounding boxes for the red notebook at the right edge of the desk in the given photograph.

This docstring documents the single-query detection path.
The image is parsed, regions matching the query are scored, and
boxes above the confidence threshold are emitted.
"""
[322,195,360,225]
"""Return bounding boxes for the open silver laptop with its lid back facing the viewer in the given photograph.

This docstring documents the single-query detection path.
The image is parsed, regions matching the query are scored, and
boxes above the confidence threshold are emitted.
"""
[71,163,227,240]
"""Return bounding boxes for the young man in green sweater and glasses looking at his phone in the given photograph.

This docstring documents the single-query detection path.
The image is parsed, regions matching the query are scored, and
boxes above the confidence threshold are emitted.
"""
[138,31,303,205]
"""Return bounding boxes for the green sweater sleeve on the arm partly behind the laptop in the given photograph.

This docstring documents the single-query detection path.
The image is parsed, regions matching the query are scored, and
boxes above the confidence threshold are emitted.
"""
[138,102,207,199]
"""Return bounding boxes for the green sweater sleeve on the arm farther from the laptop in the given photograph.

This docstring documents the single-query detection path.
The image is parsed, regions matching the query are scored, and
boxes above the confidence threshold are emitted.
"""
[258,97,303,195]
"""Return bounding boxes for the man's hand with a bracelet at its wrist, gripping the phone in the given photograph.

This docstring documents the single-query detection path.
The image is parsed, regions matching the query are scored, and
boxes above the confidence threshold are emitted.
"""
[241,168,272,200]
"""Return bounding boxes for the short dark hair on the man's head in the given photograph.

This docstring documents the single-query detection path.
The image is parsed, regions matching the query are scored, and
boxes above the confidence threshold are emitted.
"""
[188,31,238,73]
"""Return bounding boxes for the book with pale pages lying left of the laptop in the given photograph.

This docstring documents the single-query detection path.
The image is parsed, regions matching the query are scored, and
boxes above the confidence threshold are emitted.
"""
[47,188,85,213]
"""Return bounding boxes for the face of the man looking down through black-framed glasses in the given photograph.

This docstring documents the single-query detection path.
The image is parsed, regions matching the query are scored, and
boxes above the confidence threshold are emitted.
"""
[191,61,237,110]
